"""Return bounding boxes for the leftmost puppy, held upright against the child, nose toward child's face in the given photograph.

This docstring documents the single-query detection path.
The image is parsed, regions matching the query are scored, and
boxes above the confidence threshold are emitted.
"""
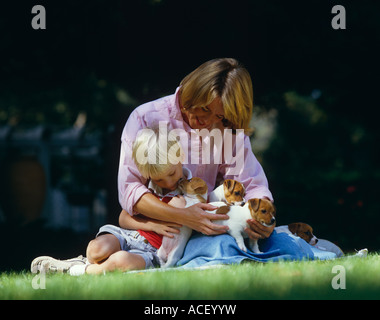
[157,177,208,268]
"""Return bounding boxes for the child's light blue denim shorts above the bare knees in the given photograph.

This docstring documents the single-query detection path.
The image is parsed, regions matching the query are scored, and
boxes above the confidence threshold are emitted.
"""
[96,224,160,269]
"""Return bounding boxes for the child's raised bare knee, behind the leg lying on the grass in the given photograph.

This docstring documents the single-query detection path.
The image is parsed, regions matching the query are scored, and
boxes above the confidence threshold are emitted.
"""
[86,233,121,263]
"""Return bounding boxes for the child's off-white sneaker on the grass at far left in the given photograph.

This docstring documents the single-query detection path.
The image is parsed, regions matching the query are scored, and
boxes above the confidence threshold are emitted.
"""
[30,255,87,273]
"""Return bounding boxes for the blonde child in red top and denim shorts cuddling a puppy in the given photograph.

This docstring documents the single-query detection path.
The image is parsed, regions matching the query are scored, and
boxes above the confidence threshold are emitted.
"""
[31,129,191,275]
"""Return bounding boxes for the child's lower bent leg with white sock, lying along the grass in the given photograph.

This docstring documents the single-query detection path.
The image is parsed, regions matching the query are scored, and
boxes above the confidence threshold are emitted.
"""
[86,251,145,274]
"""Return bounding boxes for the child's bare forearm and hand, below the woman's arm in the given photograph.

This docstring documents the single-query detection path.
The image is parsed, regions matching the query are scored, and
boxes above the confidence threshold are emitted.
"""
[119,210,181,238]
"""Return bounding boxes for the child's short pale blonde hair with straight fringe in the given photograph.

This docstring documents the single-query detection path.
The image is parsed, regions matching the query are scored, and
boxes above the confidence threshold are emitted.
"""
[132,128,183,179]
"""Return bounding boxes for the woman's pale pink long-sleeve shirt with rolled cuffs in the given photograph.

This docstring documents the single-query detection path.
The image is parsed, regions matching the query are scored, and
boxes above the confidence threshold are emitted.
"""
[118,88,273,215]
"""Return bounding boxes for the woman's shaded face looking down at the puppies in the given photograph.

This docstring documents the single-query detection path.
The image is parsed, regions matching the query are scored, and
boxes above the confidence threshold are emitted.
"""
[182,98,224,130]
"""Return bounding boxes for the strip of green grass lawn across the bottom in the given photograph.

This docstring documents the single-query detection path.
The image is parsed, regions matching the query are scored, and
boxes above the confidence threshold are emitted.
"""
[0,253,380,300]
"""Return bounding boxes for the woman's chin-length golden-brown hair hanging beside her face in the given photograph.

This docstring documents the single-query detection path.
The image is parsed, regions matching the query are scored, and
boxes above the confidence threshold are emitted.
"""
[180,58,253,135]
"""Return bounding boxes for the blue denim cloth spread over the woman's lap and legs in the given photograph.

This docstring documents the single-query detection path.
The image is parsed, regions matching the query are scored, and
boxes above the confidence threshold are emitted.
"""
[177,231,337,268]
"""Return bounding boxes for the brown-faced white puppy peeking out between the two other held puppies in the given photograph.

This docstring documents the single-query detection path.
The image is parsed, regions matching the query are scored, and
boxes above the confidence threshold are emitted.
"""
[208,179,245,206]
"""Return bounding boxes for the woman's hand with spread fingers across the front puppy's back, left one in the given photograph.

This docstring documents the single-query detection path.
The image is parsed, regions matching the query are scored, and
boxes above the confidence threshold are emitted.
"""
[183,203,229,235]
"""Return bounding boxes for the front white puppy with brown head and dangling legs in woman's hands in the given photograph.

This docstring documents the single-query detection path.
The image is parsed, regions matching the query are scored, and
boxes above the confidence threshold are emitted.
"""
[208,199,276,253]
